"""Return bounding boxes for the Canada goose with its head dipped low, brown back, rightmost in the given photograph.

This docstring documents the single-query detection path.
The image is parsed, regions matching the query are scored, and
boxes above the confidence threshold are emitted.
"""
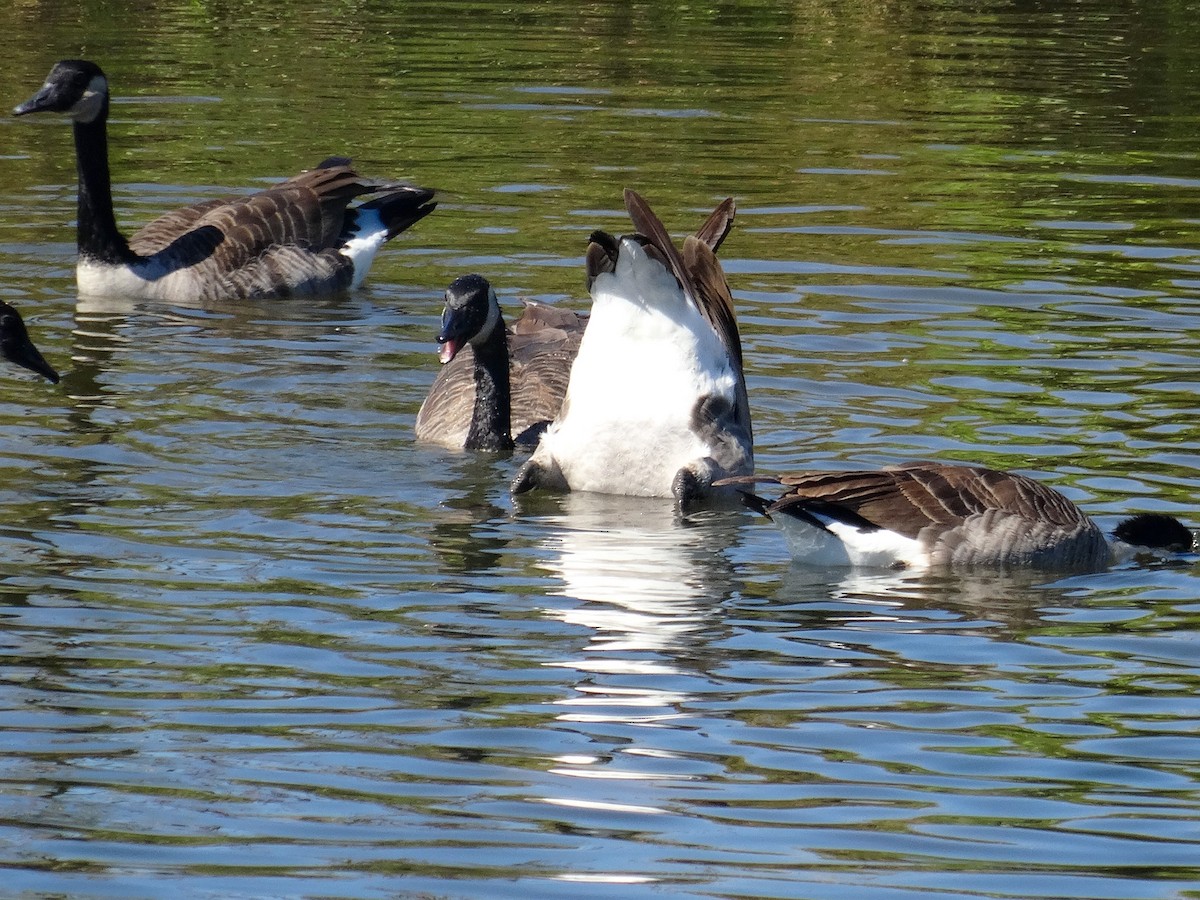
[728,462,1194,571]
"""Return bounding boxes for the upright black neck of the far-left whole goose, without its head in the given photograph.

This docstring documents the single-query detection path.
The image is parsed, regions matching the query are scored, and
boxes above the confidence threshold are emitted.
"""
[74,100,137,265]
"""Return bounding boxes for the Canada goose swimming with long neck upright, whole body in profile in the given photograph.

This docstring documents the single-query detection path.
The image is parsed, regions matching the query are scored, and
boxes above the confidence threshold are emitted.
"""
[13,60,437,302]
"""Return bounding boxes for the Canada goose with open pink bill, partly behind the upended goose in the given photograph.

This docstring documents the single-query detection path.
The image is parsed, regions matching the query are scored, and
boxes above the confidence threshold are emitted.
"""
[416,275,587,450]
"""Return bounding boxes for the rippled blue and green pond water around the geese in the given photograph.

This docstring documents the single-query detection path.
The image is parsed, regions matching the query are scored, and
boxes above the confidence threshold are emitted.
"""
[0,2,1200,900]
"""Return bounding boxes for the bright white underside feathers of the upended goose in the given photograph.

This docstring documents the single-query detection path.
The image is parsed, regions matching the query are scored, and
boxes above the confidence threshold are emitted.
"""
[539,238,737,497]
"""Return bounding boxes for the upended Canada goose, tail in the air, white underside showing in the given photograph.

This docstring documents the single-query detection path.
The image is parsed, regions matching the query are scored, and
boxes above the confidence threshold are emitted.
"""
[512,190,754,505]
